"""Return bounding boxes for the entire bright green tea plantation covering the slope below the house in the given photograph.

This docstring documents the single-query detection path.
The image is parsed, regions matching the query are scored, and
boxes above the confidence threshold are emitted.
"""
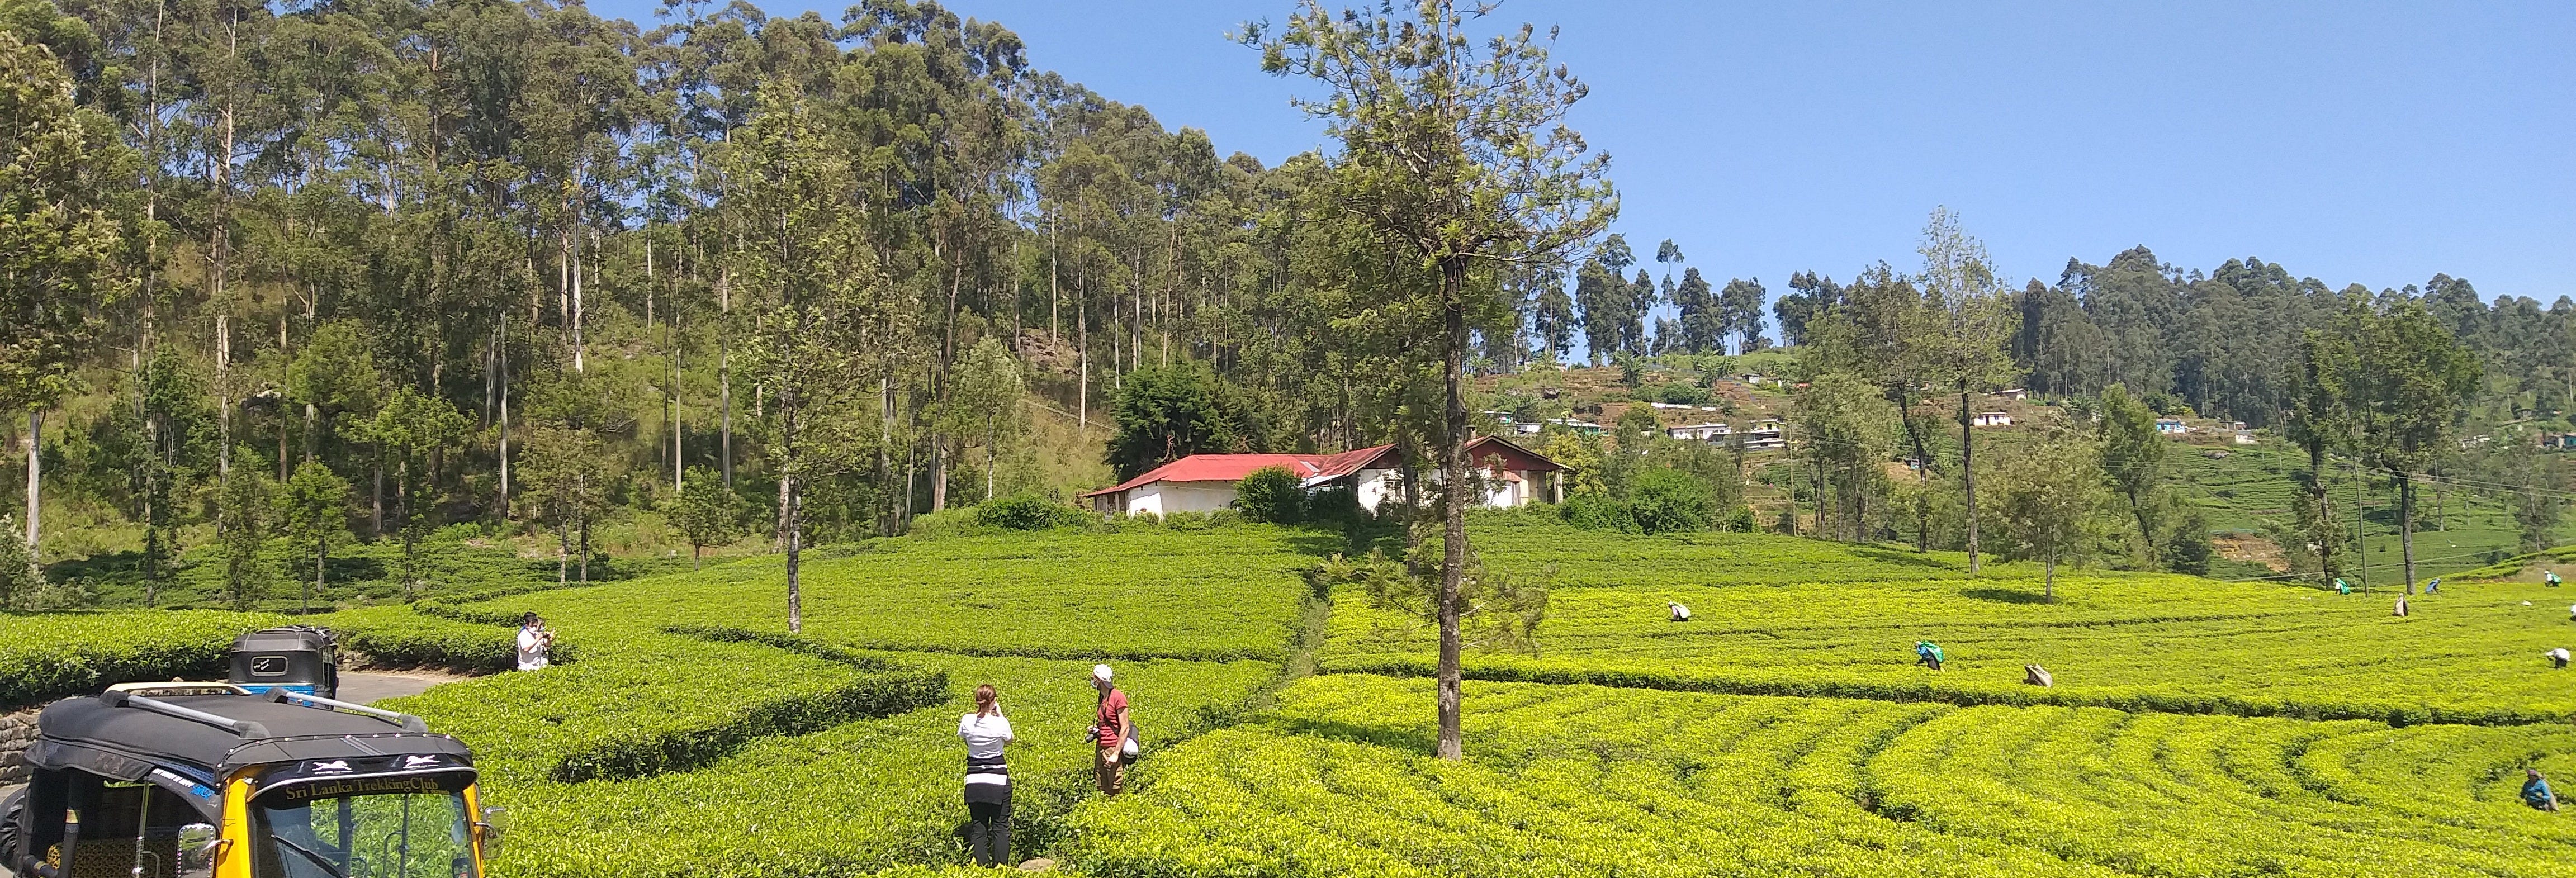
[20,520,2576,878]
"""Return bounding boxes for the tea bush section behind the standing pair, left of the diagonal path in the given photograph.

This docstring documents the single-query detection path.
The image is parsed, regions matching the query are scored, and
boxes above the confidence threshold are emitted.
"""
[378,528,1309,878]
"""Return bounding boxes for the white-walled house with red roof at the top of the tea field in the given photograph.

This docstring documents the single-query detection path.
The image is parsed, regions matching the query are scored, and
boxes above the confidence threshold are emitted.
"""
[1082,435,1564,515]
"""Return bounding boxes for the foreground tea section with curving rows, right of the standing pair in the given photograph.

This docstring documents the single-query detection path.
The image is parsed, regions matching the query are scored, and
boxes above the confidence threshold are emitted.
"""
[1067,675,2576,878]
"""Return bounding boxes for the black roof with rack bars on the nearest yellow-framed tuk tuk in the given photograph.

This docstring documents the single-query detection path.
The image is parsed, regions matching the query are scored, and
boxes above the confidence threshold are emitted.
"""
[26,692,471,777]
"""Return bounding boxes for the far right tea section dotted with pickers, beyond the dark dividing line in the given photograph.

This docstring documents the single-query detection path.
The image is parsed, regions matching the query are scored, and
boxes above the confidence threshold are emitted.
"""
[1322,528,2576,724]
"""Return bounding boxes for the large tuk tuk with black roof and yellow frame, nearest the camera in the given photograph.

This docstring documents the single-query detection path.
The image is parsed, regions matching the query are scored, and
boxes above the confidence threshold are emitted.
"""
[0,682,500,878]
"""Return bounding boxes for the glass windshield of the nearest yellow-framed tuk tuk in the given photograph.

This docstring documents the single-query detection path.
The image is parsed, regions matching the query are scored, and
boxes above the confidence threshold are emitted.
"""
[250,788,479,878]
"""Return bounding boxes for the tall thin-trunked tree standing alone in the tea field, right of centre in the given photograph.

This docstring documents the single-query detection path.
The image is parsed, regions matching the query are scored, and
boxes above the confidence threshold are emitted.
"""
[1242,0,1618,760]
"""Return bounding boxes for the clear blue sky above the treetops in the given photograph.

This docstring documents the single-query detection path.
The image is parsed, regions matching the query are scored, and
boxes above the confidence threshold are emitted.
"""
[593,0,2576,323]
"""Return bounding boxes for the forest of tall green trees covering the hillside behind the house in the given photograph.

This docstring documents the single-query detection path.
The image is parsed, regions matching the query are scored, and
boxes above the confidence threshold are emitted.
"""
[0,0,2576,613]
